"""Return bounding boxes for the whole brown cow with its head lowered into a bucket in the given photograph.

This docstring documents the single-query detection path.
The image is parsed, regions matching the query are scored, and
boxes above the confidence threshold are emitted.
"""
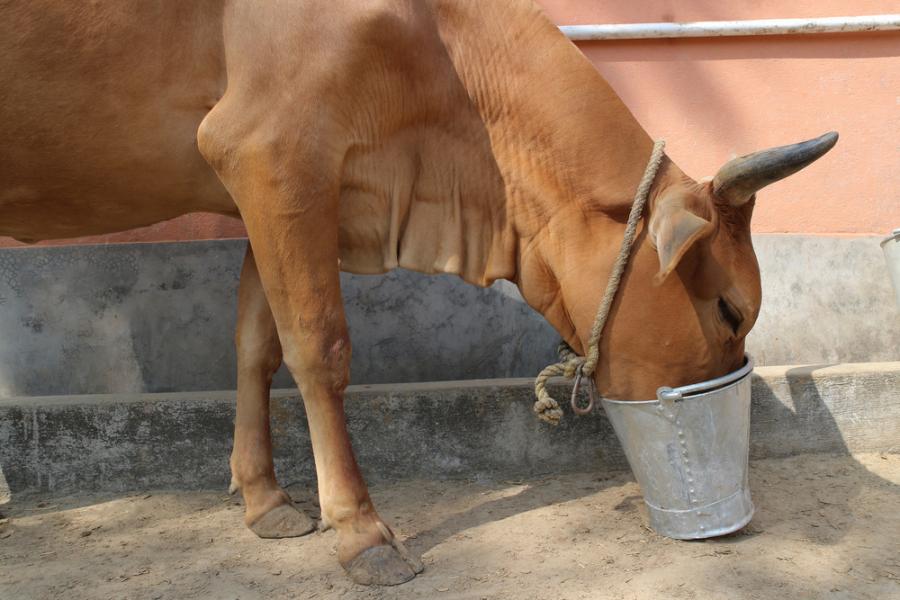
[0,0,836,584]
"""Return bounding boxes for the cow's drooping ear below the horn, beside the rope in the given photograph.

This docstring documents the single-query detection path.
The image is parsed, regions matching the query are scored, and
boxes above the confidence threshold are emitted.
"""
[650,196,715,284]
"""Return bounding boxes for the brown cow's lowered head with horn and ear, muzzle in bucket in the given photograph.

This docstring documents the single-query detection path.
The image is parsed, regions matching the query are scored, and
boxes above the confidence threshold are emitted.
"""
[536,133,838,400]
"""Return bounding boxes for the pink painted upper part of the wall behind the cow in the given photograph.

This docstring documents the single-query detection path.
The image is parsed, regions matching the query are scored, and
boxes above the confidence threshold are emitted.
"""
[0,0,900,246]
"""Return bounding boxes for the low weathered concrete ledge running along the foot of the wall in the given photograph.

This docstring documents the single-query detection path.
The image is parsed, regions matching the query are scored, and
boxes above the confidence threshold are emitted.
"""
[0,362,900,494]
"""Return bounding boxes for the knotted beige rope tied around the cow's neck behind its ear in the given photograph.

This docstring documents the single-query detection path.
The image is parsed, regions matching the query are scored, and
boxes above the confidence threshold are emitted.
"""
[534,140,666,425]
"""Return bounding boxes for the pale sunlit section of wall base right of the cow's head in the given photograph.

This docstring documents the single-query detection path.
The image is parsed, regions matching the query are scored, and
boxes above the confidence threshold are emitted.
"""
[747,235,900,365]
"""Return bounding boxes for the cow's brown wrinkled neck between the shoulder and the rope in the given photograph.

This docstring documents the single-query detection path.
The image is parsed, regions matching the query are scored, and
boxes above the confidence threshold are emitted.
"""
[435,0,652,346]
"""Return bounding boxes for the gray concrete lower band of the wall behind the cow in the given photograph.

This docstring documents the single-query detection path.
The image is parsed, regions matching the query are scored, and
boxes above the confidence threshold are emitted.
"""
[0,235,900,397]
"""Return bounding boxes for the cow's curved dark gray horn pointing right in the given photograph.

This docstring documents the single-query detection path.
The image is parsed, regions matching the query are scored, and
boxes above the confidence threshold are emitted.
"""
[713,131,838,206]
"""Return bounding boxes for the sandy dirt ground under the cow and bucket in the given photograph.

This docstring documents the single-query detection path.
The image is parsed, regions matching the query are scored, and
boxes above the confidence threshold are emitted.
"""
[0,454,900,600]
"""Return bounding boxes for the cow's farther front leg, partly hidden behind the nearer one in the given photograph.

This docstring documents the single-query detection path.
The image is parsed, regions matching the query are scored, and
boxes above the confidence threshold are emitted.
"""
[230,246,315,538]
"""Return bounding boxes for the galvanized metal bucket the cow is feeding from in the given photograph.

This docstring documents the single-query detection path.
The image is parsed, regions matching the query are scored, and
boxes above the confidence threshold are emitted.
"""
[601,356,753,540]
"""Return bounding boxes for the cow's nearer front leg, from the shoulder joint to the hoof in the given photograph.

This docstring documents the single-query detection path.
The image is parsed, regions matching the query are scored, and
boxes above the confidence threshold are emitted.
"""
[200,123,421,585]
